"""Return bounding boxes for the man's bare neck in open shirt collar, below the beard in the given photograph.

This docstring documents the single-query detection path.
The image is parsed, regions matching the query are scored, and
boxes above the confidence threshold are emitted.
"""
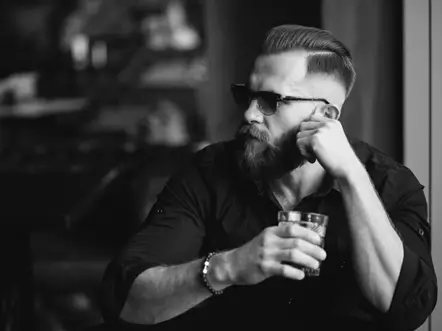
[269,161,326,209]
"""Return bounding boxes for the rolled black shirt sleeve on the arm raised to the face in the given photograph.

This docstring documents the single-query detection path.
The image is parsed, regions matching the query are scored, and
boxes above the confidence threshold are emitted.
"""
[383,167,437,330]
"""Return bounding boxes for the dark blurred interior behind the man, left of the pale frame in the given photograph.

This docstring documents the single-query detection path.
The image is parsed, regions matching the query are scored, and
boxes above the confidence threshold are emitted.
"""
[0,0,438,331]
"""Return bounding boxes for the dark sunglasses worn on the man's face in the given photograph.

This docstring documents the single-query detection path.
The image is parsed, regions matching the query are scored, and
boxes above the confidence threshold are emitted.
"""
[231,84,330,116]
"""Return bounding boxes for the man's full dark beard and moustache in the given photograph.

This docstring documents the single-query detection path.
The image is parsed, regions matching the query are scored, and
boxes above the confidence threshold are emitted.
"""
[236,125,306,180]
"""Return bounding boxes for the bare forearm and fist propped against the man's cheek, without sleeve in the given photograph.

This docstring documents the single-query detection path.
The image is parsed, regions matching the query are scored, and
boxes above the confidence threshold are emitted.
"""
[297,115,404,312]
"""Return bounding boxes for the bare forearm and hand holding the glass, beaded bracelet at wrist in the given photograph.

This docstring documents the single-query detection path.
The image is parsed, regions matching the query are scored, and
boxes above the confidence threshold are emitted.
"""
[120,220,325,324]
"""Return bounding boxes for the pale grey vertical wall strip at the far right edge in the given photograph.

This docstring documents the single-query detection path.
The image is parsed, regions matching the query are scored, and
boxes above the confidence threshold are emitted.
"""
[404,0,442,331]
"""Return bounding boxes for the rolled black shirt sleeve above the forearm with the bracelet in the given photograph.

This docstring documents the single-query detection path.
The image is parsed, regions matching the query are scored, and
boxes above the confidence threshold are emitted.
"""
[101,167,208,322]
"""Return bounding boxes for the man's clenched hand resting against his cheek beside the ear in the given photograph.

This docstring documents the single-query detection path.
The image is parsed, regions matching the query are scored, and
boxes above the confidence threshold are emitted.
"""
[297,111,360,178]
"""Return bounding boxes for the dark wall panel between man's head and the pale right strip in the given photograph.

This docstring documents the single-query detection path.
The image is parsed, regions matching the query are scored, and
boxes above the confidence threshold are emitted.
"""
[322,0,402,161]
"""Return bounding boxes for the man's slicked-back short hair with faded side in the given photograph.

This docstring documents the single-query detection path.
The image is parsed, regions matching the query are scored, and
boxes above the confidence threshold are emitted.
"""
[261,25,356,96]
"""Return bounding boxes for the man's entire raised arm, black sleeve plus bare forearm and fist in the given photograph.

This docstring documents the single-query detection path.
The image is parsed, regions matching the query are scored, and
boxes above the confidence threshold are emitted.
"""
[297,114,437,330]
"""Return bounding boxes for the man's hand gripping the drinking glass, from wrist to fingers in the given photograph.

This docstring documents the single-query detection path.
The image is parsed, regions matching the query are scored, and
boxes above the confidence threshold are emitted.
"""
[226,223,326,285]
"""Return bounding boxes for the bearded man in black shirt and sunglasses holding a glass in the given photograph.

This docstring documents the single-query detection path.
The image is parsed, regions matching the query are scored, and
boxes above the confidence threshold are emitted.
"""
[99,26,437,330]
